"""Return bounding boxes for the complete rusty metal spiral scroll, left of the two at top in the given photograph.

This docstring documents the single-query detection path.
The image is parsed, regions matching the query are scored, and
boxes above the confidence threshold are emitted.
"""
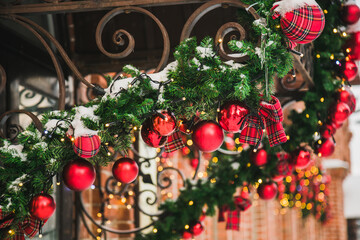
[95,7,170,72]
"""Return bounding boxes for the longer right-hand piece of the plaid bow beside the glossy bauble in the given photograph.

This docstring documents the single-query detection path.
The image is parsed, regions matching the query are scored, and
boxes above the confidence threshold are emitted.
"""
[259,96,287,147]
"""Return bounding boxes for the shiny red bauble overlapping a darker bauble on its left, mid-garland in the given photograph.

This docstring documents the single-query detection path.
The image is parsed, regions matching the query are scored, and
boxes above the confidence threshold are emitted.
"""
[152,111,176,136]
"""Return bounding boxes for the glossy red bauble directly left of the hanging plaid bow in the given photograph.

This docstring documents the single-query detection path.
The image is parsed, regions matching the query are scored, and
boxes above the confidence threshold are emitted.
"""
[218,101,250,133]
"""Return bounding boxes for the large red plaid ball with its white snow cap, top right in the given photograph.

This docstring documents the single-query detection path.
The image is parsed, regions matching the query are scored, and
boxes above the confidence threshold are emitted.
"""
[271,0,325,49]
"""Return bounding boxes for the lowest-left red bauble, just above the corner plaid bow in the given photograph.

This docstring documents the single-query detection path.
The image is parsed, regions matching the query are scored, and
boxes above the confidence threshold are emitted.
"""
[29,193,56,220]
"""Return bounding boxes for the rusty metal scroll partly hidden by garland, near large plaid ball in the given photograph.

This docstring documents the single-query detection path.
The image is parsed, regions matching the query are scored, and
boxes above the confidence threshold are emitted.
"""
[180,0,260,62]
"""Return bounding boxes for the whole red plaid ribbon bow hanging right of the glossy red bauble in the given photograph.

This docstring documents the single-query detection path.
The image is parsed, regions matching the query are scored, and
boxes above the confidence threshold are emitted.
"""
[239,96,287,149]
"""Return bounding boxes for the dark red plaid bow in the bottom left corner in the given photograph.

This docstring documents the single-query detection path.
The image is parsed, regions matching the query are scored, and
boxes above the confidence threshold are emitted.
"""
[0,209,47,240]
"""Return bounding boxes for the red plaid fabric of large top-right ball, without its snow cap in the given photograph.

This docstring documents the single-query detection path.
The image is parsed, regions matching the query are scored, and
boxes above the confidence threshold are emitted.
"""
[272,3,325,44]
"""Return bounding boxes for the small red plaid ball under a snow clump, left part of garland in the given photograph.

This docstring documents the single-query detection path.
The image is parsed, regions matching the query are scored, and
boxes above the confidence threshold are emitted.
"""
[73,135,101,158]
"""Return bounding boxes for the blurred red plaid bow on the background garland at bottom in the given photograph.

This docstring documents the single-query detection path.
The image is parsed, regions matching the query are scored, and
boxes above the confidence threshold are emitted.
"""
[218,196,251,231]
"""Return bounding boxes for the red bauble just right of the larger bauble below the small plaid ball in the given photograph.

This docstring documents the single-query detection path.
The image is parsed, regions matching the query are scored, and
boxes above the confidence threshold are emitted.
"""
[112,157,139,183]
